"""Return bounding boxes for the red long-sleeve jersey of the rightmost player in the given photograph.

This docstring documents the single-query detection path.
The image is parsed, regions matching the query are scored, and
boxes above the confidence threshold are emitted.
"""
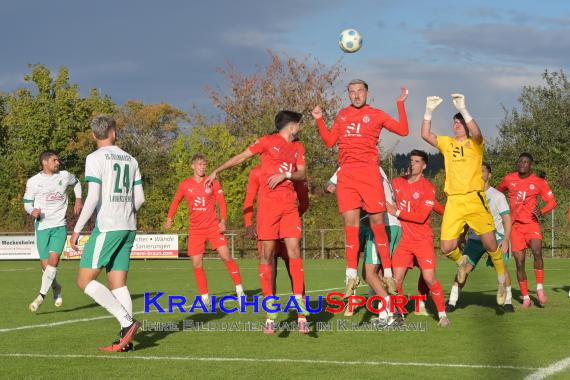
[496,172,556,224]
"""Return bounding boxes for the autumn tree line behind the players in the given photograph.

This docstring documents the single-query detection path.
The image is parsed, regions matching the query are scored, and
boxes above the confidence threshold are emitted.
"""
[0,58,570,252]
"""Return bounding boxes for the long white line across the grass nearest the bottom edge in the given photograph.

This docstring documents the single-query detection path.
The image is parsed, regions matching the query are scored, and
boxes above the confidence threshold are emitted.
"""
[0,353,542,371]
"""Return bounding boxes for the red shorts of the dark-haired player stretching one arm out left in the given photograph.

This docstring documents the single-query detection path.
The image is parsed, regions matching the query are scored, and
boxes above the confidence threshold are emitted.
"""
[257,194,303,240]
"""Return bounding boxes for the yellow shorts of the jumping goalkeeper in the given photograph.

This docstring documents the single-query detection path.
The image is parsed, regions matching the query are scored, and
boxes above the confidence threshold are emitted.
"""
[441,191,495,240]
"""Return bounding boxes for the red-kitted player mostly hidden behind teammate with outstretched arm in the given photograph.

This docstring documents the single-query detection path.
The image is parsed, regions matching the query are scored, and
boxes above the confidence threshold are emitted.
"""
[243,165,309,295]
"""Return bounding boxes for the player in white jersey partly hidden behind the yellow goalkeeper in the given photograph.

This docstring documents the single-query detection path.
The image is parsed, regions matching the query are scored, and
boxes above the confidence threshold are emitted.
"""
[445,162,515,313]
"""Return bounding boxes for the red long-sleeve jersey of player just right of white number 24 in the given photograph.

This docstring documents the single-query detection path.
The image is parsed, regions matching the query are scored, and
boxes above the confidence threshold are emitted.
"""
[168,177,228,232]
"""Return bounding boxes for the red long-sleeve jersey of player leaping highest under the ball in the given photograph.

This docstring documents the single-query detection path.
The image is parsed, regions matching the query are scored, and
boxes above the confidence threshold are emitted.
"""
[317,101,409,166]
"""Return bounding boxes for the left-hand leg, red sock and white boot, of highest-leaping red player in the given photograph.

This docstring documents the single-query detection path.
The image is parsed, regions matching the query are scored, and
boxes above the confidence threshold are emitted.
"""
[342,209,360,297]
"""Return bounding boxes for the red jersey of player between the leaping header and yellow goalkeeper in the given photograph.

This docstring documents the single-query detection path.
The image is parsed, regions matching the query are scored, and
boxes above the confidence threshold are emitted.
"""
[392,176,436,241]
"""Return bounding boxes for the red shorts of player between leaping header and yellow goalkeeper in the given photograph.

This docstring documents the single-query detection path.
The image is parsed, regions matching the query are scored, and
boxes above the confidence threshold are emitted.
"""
[392,240,435,269]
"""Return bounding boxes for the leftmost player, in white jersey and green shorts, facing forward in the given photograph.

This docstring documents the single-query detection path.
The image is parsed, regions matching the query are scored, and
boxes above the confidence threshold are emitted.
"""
[24,150,83,312]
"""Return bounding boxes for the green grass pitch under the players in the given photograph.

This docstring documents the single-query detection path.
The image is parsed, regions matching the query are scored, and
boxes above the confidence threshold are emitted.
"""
[0,259,570,379]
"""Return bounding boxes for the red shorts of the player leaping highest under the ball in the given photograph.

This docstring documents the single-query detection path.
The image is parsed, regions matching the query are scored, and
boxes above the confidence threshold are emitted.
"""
[336,163,386,214]
